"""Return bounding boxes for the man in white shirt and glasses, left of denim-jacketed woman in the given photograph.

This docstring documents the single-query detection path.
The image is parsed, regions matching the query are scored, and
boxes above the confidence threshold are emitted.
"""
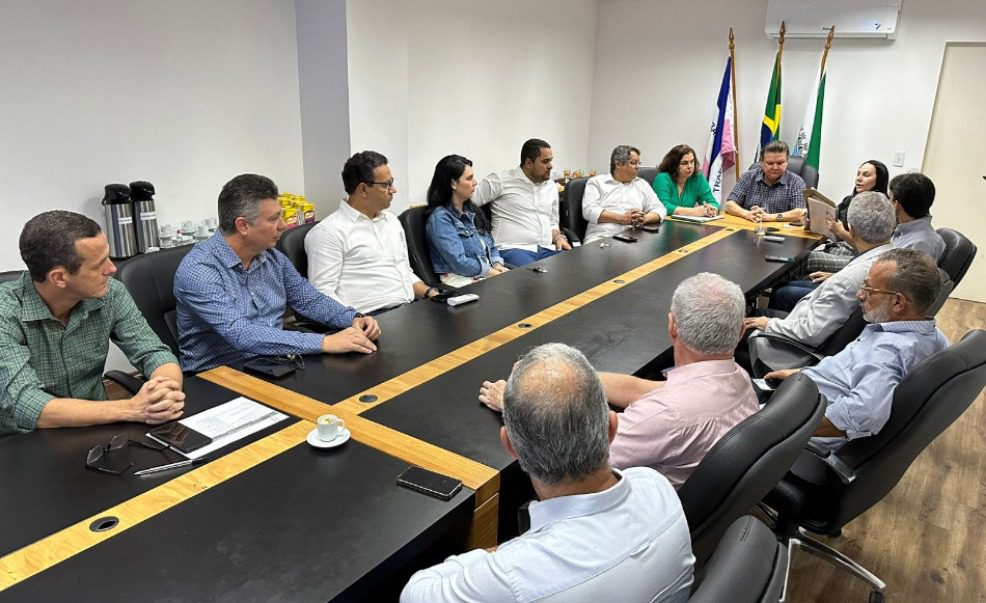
[305,151,438,314]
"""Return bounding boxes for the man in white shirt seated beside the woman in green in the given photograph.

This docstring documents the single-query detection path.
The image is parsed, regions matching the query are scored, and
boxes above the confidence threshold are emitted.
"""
[582,144,668,243]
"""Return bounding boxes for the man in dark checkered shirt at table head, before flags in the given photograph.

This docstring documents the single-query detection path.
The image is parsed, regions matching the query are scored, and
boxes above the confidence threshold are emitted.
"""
[726,140,805,222]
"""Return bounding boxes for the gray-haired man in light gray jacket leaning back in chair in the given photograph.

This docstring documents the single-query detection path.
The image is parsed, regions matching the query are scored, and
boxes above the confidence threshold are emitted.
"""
[746,191,897,360]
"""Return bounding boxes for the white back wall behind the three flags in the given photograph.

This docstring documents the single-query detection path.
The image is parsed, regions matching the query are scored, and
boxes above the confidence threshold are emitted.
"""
[589,0,986,196]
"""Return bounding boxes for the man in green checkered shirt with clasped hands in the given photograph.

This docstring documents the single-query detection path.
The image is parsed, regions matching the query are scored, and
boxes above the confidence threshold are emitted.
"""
[0,210,185,436]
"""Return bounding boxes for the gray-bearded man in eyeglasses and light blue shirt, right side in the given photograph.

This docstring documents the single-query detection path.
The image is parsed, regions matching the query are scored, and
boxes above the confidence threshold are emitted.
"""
[766,250,948,451]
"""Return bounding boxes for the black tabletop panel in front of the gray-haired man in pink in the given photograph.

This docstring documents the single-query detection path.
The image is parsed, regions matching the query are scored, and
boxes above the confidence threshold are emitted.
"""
[362,232,811,471]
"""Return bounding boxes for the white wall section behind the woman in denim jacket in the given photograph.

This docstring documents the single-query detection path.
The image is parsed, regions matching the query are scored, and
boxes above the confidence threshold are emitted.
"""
[347,0,597,212]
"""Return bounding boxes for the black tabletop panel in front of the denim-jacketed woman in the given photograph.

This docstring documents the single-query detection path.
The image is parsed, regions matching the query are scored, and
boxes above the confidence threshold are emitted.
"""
[234,222,716,403]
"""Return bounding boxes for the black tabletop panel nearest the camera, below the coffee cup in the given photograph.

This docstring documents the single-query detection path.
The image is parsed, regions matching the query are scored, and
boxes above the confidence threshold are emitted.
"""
[0,440,474,601]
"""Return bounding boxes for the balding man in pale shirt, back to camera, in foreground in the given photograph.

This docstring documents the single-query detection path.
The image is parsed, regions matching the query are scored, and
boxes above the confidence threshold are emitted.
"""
[401,343,695,603]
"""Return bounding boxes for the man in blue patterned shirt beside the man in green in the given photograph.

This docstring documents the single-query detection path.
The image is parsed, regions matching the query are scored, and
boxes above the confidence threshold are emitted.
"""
[174,174,380,372]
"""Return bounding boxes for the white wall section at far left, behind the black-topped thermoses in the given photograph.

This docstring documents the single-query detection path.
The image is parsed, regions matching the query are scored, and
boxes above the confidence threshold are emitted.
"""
[0,0,304,269]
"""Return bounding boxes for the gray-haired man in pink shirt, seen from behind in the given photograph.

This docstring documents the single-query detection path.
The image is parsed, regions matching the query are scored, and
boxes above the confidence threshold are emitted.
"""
[479,272,759,488]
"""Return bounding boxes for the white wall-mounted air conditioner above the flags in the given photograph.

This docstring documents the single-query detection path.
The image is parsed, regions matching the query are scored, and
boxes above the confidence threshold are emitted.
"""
[764,0,903,39]
